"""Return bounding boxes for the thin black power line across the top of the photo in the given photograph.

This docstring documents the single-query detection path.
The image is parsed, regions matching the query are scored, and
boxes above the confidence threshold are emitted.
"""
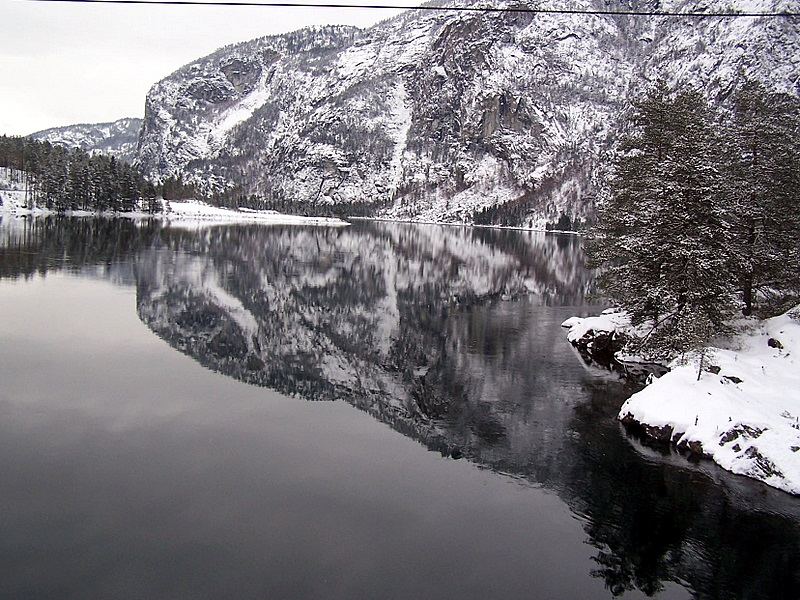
[23,0,800,19]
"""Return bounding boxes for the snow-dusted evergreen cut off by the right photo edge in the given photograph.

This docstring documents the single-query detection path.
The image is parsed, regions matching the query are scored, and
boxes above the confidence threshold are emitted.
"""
[724,81,800,315]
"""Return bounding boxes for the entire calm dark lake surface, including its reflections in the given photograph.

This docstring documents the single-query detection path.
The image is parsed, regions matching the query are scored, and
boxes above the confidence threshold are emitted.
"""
[0,220,800,599]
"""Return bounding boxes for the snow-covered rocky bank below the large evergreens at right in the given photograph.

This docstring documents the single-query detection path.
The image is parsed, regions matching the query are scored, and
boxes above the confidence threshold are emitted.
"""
[563,307,800,495]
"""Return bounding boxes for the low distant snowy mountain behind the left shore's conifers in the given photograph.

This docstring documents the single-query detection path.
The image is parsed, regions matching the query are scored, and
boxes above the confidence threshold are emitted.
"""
[28,117,142,163]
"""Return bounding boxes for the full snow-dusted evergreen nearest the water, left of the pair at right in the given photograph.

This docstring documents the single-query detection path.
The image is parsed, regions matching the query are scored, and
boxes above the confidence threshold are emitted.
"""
[587,81,733,355]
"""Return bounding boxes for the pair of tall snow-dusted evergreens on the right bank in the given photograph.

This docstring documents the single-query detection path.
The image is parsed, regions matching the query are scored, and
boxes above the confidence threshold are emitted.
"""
[587,81,800,356]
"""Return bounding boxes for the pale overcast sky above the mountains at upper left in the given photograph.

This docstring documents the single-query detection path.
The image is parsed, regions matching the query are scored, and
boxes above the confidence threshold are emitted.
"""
[0,0,420,135]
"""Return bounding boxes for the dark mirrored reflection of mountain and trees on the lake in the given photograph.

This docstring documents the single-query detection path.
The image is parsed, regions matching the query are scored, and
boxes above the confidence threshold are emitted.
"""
[0,219,800,598]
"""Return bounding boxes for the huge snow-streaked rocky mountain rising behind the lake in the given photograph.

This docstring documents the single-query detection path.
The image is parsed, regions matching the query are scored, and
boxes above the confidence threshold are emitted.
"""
[138,0,800,226]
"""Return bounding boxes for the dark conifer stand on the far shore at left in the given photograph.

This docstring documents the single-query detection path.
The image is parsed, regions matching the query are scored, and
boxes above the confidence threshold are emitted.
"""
[0,136,161,213]
